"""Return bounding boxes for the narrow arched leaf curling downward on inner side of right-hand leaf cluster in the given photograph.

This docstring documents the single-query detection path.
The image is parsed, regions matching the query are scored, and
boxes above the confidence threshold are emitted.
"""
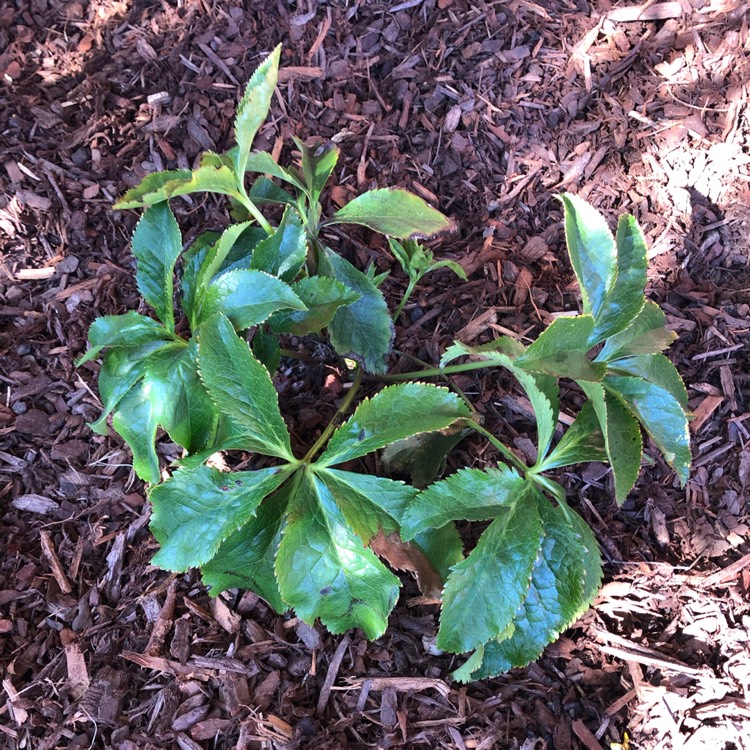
[440,340,559,460]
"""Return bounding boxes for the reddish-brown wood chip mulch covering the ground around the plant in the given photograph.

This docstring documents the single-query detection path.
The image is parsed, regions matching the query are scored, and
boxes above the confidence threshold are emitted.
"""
[0,0,750,750]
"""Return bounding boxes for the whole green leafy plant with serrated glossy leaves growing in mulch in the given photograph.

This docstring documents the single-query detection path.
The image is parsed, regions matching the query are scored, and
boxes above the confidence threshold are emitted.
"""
[81,44,690,680]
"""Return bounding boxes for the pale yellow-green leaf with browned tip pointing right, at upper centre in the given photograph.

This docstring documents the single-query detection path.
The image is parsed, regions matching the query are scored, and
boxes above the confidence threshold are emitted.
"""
[327,188,454,239]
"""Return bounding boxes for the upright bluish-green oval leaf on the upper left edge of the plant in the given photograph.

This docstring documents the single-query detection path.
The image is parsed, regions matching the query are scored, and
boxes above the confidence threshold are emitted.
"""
[132,203,182,331]
